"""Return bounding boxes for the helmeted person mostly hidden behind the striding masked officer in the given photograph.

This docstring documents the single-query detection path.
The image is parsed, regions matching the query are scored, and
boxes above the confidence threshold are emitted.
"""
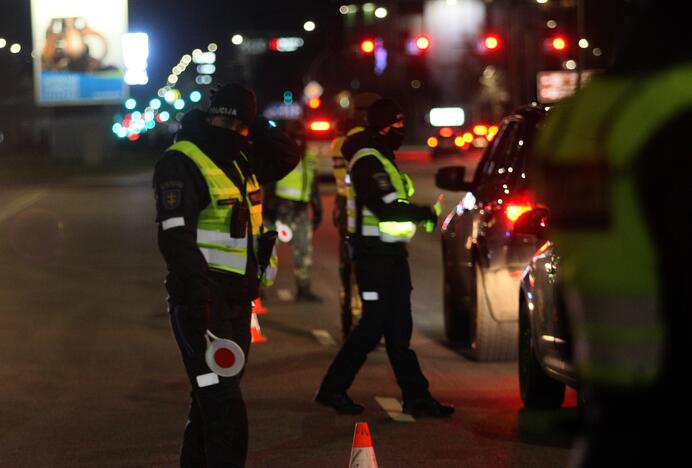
[331,92,381,340]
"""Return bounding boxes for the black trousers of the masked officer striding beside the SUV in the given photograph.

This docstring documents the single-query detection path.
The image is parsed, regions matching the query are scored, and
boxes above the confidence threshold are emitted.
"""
[321,256,430,401]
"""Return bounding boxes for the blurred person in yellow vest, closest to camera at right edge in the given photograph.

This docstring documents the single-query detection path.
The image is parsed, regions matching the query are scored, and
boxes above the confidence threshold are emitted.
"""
[534,2,692,467]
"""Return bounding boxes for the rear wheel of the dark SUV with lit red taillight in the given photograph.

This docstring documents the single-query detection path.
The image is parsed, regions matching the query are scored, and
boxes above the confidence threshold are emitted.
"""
[470,264,517,361]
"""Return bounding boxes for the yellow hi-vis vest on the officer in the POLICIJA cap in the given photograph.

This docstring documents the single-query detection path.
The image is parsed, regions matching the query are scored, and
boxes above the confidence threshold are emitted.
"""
[166,141,262,275]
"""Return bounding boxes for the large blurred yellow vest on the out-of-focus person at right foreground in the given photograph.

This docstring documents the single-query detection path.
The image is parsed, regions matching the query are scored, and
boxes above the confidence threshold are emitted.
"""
[532,63,692,387]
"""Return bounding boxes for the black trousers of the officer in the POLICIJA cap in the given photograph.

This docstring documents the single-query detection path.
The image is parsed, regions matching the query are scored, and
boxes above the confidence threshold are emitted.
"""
[169,280,251,468]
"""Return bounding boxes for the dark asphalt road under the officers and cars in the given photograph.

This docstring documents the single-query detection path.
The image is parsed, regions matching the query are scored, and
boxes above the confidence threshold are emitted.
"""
[0,151,577,468]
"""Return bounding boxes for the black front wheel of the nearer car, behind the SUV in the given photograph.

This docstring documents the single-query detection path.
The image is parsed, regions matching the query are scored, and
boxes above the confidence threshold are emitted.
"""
[519,300,565,409]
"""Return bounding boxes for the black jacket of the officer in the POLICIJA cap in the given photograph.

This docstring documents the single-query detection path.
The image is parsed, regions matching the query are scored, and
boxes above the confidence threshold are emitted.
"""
[153,110,300,312]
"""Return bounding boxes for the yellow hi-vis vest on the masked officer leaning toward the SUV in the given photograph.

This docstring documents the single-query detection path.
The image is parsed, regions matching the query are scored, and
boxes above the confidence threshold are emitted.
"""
[346,148,416,242]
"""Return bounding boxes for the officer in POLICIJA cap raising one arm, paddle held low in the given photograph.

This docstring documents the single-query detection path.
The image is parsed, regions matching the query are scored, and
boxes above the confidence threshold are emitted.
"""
[153,84,299,467]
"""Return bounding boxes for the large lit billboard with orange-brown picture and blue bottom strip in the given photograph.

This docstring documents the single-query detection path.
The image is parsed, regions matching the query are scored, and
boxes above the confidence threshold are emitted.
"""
[31,0,128,106]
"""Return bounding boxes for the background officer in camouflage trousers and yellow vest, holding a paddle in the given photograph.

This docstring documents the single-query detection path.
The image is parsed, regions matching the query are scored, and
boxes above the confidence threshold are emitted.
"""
[264,120,322,302]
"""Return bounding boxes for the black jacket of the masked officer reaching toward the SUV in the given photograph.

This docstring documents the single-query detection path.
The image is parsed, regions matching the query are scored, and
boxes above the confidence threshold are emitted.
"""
[342,129,437,259]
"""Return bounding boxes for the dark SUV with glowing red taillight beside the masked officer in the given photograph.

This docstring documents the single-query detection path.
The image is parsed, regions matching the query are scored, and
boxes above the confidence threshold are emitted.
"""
[436,104,547,361]
